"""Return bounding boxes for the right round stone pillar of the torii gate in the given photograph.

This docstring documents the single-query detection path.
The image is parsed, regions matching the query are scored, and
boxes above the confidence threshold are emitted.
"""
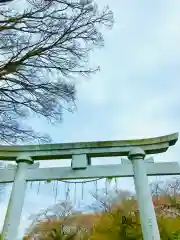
[129,147,160,240]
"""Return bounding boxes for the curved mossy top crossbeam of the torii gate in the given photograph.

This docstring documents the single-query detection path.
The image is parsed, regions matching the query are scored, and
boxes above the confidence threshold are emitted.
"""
[0,133,178,161]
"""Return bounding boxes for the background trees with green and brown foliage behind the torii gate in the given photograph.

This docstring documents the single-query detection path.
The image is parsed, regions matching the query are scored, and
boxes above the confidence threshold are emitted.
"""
[25,178,180,240]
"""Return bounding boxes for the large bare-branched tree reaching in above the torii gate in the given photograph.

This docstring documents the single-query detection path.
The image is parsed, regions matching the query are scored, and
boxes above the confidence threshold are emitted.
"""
[0,0,113,143]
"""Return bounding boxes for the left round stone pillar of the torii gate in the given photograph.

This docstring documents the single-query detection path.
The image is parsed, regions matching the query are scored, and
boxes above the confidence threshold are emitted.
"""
[2,156,33,240]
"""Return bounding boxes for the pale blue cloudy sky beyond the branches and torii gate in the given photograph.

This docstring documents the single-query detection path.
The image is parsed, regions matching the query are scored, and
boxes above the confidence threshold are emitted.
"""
[1,0,180,238]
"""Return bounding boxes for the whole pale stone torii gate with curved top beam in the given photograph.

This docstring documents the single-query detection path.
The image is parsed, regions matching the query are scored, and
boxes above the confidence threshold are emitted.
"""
[0,133,180,240]
